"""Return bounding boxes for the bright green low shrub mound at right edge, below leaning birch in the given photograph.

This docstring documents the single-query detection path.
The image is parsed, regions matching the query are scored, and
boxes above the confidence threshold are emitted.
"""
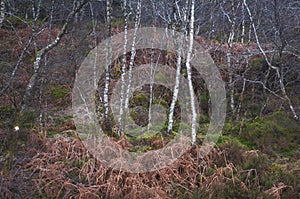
[239,112,300,156]
